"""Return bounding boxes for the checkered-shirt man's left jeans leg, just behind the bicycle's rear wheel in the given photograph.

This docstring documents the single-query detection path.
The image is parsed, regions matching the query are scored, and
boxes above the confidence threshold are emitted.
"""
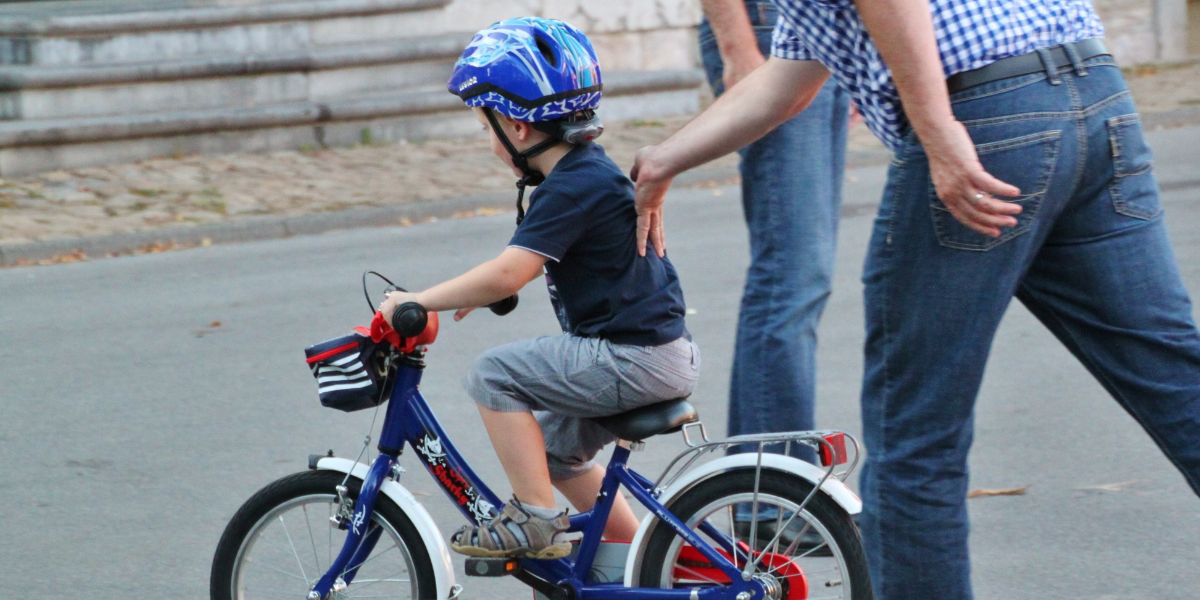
[859,83,1079,600]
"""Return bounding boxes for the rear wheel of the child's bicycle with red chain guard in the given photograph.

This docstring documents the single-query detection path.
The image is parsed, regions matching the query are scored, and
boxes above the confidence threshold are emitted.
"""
[637,469,872,600]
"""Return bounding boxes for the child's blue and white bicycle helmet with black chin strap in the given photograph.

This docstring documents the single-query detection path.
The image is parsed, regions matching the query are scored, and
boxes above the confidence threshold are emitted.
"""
[446,17,604,224]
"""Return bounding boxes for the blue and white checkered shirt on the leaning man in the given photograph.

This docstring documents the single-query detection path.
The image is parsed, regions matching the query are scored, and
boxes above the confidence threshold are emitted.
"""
[772,0,1104,150]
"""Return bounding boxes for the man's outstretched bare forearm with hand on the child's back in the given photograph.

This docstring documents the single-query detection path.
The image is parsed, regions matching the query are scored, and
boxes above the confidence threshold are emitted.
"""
[630,56,829,257]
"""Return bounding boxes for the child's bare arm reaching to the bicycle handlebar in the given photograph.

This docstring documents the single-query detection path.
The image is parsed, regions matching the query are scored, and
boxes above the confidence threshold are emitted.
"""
[379,247,547,325]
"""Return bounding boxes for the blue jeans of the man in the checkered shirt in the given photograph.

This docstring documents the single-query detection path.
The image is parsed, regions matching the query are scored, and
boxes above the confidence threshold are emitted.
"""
[860,56,1200,600]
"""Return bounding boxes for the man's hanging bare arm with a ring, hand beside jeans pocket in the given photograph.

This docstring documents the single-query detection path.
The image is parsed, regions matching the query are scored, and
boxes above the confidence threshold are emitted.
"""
[854,0,1021,238]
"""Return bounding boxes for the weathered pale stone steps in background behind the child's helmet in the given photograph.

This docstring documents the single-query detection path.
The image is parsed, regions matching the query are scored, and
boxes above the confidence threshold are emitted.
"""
[0,0,701,176]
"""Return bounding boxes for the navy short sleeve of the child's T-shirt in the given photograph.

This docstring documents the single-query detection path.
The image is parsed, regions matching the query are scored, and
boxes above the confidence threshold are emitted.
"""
[509,186,588,262]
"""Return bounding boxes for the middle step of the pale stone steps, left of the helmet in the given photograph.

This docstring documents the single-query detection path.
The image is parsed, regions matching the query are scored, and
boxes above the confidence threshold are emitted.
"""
[0,34,469,120]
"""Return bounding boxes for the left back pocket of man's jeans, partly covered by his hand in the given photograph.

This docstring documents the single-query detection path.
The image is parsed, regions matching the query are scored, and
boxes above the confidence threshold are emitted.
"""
[929,131,1062,252]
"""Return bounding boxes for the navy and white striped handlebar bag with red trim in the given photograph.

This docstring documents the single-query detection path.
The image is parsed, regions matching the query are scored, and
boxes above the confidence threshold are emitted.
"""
[304,334,385,413]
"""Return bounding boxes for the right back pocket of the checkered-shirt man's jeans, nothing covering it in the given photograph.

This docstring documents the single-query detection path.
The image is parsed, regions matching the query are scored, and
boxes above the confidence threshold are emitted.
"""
[1105,114,1163,221]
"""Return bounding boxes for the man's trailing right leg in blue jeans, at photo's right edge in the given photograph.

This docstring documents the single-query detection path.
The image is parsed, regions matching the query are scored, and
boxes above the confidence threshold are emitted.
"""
[1018,66,1200,496]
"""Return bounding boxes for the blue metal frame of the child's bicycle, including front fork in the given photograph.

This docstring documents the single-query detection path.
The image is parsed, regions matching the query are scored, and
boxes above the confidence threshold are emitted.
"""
[308,354,763,600]
